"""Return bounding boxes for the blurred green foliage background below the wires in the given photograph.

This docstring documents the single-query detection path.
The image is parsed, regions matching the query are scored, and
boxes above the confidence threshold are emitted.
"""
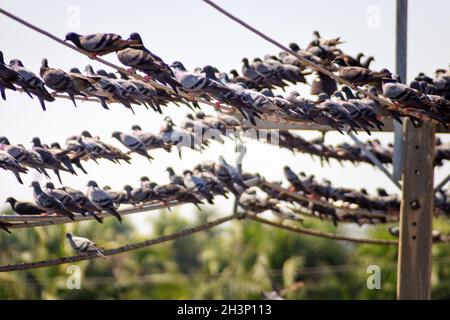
[0,208,450,299]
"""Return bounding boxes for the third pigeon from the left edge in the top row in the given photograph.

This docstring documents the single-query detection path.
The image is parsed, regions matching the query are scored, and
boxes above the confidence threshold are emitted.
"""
[40,58,86,107]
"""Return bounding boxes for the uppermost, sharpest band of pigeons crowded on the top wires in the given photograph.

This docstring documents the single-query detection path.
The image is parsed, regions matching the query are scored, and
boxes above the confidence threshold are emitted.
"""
[0,32,450,132]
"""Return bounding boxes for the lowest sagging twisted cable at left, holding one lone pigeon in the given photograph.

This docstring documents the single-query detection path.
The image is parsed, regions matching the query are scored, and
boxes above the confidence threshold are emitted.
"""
[0,215,238,272]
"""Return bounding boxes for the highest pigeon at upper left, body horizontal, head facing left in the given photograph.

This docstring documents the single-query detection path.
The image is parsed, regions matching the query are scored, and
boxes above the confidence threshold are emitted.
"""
[64,32,138,58]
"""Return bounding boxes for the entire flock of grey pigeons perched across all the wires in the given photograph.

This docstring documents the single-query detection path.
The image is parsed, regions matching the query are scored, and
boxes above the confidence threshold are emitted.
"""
[0,28,450,246]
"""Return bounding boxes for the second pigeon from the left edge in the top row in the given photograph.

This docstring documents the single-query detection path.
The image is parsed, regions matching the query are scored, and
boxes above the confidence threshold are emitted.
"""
[9,59,55,111]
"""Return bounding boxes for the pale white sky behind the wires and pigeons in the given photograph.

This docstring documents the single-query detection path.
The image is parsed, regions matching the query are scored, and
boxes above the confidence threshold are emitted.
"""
[0,0,450,231]
